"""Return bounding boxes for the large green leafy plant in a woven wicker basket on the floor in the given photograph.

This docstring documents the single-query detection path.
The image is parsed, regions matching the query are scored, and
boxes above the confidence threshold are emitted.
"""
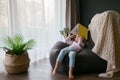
[2,34,35,74]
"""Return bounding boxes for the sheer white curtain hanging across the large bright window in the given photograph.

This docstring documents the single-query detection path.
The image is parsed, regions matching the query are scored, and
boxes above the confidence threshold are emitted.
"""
[0,0,66,62]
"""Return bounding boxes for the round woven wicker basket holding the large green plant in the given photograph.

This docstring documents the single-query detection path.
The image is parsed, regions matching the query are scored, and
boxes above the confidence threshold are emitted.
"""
[4,52,30,74]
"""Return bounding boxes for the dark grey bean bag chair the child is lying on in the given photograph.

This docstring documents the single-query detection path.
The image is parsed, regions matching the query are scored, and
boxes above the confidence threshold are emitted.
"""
[49,33,107,74]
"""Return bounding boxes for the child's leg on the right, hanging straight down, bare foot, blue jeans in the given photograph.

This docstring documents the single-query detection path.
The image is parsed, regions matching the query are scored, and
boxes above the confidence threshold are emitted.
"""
[69,51,77,79]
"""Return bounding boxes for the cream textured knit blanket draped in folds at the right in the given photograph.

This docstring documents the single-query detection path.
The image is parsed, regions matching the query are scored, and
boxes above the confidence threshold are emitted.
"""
[89,10,120,77]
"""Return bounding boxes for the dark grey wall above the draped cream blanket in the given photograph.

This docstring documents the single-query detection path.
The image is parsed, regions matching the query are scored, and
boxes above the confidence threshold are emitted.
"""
[80,0,120,26]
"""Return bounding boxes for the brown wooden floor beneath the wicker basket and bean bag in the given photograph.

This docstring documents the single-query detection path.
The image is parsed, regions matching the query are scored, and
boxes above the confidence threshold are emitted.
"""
[0,59,120,80]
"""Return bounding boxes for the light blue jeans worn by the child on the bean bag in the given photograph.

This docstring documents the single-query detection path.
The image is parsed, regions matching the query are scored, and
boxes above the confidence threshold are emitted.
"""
[57,47,77,67]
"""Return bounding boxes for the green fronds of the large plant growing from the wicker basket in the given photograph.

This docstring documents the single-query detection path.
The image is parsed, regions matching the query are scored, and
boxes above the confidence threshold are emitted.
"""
[3,34,35,55]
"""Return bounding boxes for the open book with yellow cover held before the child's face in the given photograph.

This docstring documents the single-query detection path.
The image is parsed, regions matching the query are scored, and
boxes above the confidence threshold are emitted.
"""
[71,23,88,40]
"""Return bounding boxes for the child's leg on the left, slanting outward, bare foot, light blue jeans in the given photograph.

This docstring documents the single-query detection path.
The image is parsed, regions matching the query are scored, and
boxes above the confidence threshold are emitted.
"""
[52,47,70,75]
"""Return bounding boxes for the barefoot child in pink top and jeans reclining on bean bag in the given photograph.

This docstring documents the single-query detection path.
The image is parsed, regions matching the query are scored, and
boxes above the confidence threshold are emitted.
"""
[52,35,85,79]
